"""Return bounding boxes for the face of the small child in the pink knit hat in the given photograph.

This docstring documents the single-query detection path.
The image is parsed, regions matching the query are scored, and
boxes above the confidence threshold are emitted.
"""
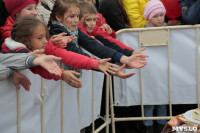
[150,12,165,27]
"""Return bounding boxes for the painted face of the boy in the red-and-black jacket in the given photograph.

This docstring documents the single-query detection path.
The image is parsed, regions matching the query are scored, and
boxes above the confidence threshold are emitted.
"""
[79,13,97,33]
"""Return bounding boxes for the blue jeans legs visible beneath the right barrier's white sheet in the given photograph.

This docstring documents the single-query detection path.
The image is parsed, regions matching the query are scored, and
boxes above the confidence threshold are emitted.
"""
[143,105,167,126]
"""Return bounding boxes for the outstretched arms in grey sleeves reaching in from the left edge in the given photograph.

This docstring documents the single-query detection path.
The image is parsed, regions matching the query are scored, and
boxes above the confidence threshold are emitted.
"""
[0,50,61,91]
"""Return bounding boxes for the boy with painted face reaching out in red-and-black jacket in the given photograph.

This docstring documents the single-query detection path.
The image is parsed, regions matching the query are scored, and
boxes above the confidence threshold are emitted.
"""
[79,2,145,56]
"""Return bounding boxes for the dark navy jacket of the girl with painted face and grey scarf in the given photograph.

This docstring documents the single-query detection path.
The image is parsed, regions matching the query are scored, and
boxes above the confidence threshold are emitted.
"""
[50,24,123,62]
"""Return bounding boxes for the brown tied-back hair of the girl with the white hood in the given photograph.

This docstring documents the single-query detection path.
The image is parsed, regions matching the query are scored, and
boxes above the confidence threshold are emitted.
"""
[11,17,48,50]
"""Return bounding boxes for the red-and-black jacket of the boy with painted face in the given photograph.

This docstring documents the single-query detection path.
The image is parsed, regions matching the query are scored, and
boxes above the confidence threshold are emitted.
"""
[78,25,133,56]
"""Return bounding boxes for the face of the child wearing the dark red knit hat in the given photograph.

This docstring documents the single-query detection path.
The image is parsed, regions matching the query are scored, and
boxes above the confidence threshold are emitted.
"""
[16,4,38,18]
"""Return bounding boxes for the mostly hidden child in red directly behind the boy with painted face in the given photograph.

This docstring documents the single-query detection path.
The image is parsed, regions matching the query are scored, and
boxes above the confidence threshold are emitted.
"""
[78,0,116,38]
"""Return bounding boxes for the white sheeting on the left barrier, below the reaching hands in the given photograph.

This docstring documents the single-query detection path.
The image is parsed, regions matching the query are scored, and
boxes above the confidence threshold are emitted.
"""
[0,70,103,133]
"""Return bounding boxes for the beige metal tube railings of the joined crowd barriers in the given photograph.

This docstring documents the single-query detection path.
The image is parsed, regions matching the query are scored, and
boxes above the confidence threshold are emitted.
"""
[14,25,200,133]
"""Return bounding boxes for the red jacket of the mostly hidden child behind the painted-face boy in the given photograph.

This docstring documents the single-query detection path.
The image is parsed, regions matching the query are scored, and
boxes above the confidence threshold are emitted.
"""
[96,13,116,38]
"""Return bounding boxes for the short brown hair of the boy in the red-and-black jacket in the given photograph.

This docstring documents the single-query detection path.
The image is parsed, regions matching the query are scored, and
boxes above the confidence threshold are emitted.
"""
[79,2,97,18]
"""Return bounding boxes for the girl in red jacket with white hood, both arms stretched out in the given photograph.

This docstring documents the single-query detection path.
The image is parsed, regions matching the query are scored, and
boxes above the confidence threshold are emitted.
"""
[2,17,119,88]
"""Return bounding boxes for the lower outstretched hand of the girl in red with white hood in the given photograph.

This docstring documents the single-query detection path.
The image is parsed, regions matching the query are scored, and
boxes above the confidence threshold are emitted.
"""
[62,70,82,88]
